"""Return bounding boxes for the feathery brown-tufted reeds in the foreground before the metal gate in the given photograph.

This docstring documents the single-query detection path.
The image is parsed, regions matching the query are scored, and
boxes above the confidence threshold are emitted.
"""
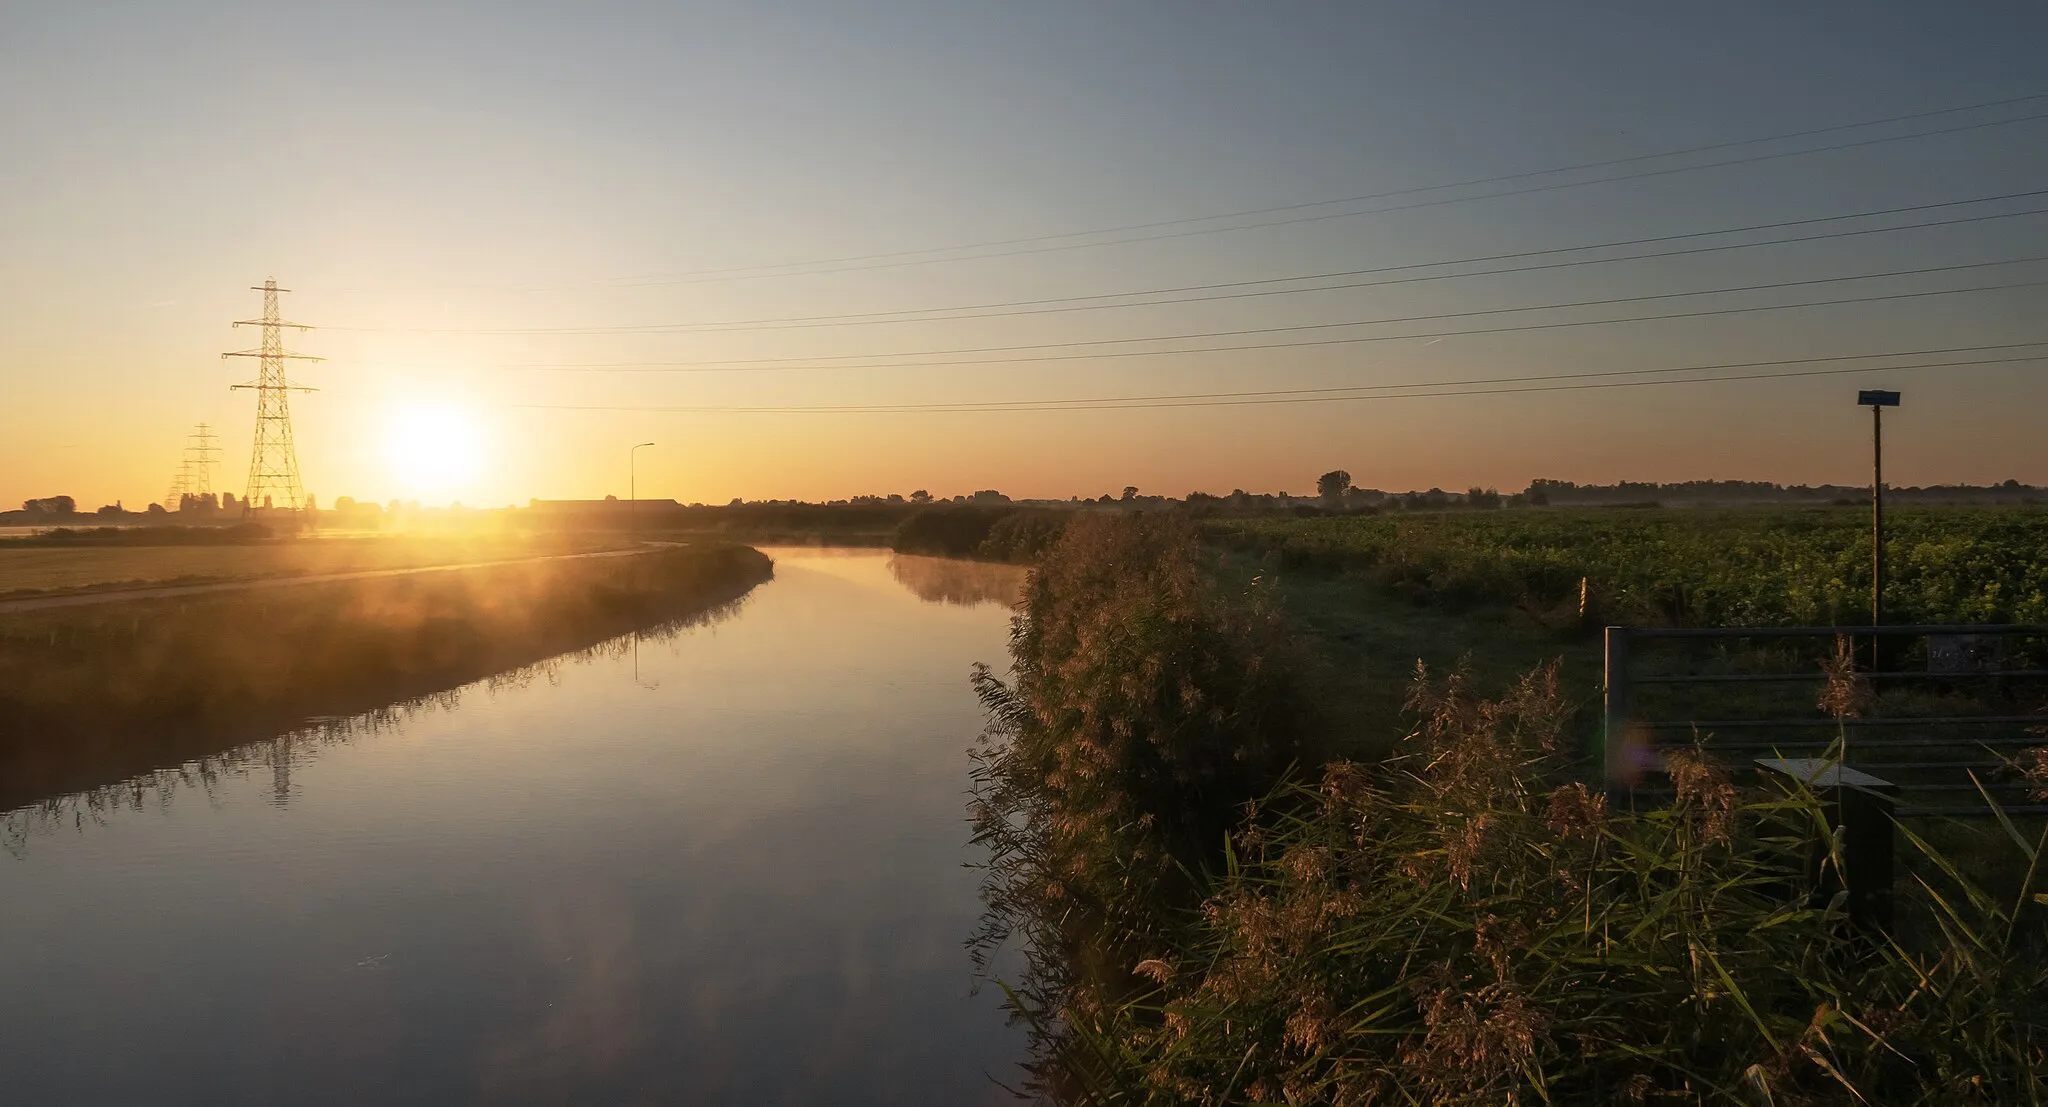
[1040,671,2048,1105]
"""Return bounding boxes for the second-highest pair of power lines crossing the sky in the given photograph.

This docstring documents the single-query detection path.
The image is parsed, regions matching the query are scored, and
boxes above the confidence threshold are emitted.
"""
[334,188,2048,336]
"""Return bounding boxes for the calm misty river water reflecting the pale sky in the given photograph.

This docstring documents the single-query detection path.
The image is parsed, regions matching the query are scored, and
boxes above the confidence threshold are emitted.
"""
[0,550,1022,1105]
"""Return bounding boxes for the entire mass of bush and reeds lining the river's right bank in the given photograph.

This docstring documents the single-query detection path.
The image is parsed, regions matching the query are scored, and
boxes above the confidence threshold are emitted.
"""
[975,518,2048,1105]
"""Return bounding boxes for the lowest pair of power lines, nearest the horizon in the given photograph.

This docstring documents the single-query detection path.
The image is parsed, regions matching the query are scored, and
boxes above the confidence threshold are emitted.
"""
[504,342,2048,415]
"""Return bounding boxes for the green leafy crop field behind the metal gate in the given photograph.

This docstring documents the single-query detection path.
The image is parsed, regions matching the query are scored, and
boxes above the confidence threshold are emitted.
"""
[1204,505,2048,626]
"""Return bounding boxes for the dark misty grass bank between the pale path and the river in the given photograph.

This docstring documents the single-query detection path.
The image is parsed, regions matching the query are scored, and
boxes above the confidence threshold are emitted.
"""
[0,544,774,808]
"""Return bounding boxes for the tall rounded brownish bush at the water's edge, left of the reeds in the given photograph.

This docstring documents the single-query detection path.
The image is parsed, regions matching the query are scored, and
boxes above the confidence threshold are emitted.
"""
[973,514,1307,1055]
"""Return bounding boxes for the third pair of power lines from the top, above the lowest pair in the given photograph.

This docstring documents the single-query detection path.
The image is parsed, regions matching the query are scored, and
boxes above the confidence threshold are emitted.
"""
[468,256,2048,372]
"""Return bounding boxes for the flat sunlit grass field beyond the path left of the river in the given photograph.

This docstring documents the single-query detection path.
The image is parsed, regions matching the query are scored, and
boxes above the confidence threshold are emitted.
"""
[0,534,616,595]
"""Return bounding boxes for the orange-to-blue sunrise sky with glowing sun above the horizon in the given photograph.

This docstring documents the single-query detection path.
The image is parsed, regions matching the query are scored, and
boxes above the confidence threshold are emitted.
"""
[0,0,2048,507]
